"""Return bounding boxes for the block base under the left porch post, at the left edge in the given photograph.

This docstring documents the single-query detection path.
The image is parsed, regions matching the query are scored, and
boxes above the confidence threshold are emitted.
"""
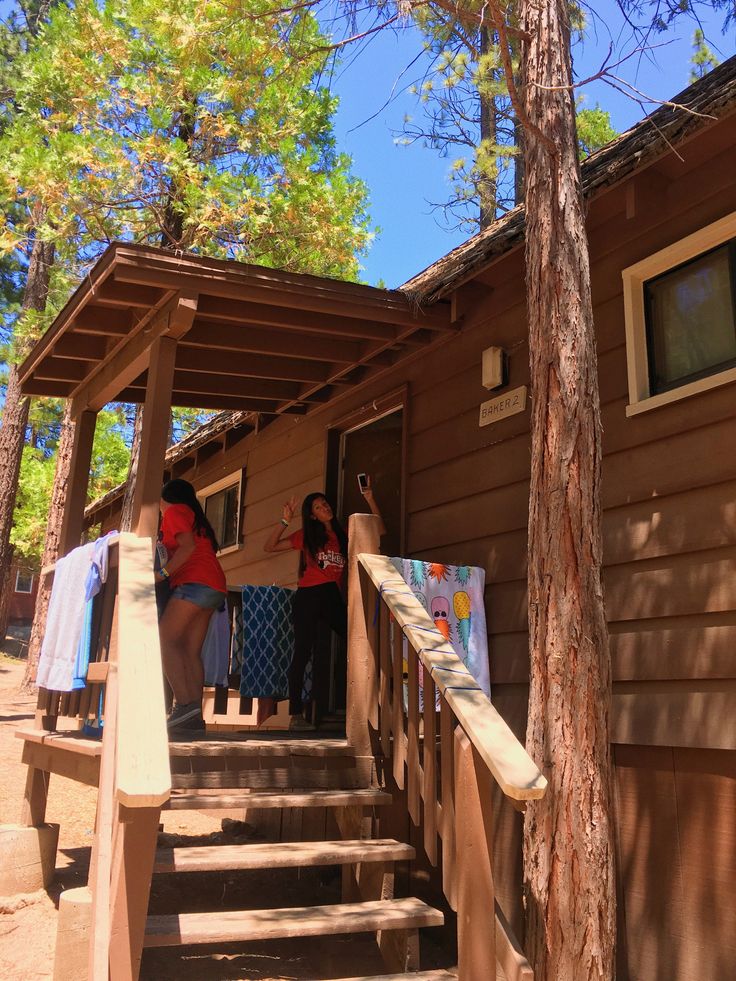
[0,824,59,896]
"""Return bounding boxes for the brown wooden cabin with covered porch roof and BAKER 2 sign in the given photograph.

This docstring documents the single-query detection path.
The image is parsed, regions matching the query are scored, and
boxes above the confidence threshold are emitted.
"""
[7,59,736,981]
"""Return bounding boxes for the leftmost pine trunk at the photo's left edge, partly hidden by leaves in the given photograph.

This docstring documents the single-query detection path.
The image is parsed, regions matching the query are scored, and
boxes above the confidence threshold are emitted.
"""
[0,238,54,639]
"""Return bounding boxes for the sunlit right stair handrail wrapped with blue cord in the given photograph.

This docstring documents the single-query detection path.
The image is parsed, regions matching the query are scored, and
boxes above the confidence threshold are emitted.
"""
[357,553,547,801]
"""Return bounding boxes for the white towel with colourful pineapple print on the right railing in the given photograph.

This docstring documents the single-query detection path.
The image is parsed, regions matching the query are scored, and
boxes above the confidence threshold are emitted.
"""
[391,558,491,698]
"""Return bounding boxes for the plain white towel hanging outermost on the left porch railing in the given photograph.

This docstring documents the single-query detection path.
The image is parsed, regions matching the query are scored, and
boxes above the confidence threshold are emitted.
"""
[36,542,95,691]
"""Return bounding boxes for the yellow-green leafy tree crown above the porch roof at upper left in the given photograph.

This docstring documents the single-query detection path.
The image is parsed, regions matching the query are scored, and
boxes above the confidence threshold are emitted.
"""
[0,0,370,279]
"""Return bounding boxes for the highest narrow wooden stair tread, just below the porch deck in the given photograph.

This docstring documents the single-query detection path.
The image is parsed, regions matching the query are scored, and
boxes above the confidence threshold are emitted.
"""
[164,789,391,811]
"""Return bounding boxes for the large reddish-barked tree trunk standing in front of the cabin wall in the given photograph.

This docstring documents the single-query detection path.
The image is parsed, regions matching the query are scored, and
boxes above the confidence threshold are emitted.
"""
[520,0,616,981]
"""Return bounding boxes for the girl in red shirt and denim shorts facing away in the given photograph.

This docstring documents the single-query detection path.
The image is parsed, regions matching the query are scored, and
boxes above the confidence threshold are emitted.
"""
[156,480,227,732]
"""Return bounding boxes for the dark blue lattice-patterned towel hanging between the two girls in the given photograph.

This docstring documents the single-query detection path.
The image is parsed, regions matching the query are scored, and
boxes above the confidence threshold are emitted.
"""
[240,586,294,699]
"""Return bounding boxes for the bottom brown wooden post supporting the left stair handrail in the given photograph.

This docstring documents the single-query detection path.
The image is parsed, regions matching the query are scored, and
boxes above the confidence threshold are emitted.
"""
[110,804,161,981]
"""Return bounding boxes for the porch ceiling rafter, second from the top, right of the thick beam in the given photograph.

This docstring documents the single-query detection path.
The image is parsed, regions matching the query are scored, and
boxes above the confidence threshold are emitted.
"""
[185,316,364,364]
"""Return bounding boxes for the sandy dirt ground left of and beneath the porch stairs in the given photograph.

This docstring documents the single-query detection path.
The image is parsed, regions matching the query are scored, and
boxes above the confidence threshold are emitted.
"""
[0,654,452,981]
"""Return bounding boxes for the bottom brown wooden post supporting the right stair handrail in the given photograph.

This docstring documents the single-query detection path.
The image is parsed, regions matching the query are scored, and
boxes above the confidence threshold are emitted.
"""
[455,728,496,981]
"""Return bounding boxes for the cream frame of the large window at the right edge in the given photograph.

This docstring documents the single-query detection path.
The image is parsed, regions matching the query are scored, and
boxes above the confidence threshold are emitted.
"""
[621,212,736,416]
